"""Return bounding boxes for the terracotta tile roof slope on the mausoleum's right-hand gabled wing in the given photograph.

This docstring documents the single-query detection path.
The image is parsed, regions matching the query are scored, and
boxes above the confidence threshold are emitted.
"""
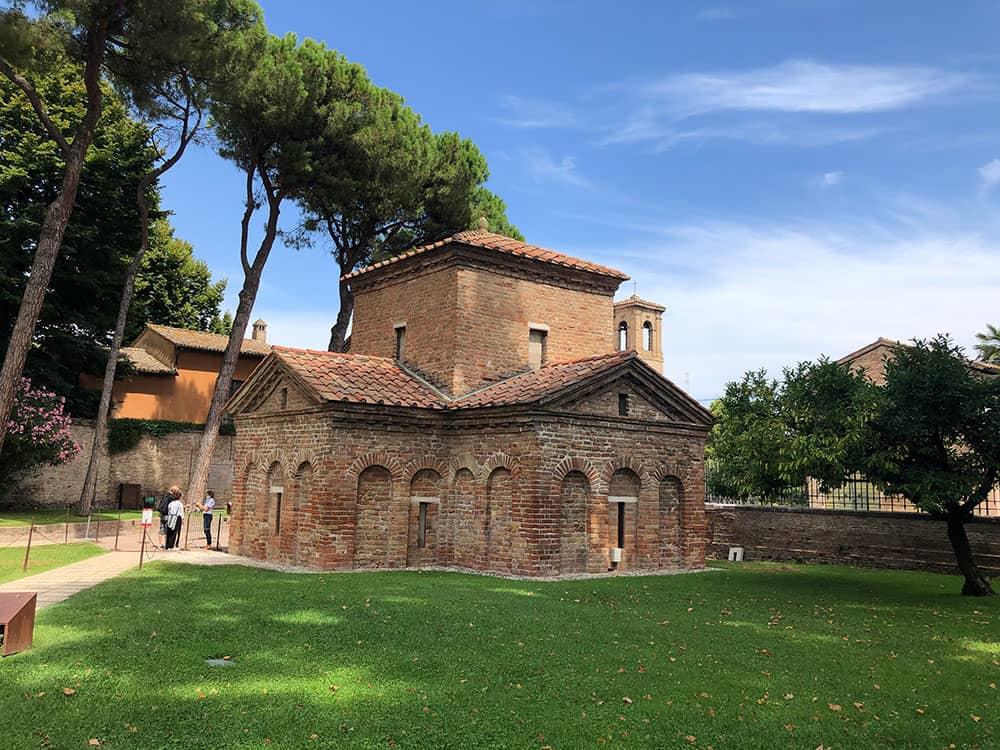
[450,351,636,409]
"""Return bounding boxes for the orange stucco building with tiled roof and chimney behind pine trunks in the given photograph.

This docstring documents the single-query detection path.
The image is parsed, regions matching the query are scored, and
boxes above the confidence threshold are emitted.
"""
[109,320,271,424]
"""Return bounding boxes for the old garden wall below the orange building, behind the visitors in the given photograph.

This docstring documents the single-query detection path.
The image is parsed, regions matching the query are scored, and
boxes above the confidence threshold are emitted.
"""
[5,420,233,507]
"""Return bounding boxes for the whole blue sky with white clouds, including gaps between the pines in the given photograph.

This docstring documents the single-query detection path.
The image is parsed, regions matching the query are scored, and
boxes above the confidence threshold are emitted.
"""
[164,0,1000,401]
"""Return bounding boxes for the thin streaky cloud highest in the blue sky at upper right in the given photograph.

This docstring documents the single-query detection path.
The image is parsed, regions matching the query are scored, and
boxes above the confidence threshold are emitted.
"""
[638,60,970,117]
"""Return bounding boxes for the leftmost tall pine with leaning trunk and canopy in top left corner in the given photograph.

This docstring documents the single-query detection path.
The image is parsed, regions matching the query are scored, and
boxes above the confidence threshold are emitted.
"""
[0,0,262,458]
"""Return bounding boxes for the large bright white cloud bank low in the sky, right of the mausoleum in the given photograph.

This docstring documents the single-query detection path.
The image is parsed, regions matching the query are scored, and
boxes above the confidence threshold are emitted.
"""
[585,209,1000,399]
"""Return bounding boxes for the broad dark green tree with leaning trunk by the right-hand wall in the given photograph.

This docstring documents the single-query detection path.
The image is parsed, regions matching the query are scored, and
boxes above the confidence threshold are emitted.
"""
[711,336,1000,596]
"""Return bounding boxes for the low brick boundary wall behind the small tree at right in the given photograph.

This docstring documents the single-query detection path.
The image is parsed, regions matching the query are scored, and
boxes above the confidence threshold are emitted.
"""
[705,504,1000,577]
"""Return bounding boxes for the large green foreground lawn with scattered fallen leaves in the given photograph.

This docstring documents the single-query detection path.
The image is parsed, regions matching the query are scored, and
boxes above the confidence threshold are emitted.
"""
[0,562,1000,750]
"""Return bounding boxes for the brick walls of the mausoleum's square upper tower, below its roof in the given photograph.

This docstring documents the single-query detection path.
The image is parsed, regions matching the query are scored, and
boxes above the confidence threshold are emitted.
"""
[351,250,618,395]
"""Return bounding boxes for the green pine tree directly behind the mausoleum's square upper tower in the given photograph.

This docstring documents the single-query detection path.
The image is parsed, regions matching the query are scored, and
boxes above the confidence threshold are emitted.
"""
[300,104,523,351]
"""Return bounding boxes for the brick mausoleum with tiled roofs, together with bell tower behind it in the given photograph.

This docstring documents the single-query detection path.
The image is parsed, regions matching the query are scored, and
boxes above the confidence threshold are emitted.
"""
[230,231,711,576]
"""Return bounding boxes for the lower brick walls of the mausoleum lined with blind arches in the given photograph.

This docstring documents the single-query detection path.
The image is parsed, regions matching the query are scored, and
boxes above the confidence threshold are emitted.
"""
[232,406,705,576]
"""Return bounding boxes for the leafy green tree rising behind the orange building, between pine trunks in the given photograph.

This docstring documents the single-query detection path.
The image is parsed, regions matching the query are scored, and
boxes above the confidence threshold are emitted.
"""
[125,219,232,340]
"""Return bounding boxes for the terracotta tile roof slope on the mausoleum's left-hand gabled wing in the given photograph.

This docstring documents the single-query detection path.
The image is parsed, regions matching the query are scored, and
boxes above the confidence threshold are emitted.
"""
[272,346,444,409]
